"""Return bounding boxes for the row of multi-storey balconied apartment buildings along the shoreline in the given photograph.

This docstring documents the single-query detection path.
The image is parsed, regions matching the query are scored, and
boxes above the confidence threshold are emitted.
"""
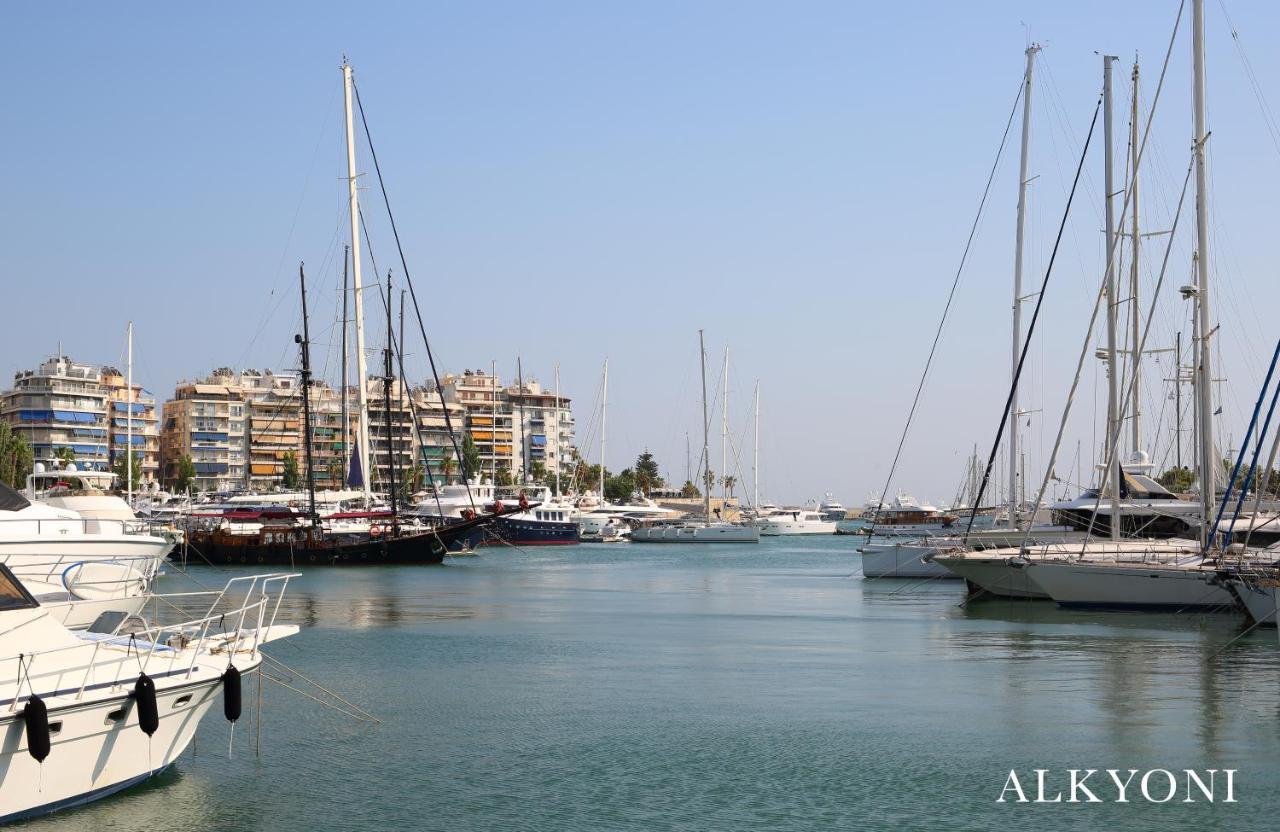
[0,356,575,492]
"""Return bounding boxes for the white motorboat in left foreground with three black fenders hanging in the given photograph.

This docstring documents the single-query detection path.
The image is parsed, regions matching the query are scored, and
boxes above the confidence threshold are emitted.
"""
[0,567,297,823]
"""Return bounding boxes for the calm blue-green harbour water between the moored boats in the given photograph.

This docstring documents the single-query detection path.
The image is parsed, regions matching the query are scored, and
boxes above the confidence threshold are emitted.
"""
[23,538,1280,832]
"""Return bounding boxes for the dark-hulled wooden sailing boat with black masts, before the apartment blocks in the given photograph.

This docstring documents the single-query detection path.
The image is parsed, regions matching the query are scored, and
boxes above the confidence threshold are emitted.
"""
[188,265,504,567]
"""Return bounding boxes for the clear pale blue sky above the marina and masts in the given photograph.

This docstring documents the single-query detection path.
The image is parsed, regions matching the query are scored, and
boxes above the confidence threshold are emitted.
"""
[0,0,1280,504]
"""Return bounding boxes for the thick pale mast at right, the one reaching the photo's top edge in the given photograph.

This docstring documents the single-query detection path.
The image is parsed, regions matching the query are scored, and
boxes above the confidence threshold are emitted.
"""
[1192,0,1217,545]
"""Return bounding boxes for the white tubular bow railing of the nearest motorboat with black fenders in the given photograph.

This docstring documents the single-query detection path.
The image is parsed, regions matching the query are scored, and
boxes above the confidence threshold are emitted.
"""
[8,572,301,712]
